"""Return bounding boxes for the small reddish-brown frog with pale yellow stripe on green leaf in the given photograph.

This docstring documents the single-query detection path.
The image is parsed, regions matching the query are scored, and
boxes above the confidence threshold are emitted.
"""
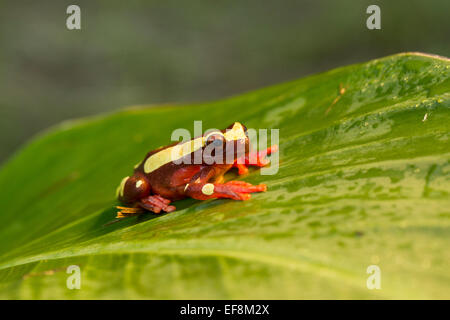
[116,122,278,218]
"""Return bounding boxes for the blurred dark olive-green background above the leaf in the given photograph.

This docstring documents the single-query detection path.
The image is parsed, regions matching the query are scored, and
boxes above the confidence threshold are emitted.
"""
[0,0,450,163]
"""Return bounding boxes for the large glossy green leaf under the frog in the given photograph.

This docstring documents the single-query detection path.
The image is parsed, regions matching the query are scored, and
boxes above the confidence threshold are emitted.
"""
[0,54,450,299]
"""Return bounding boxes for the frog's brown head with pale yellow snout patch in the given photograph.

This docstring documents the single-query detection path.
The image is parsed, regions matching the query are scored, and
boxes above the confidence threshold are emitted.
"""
[203,122,249,164]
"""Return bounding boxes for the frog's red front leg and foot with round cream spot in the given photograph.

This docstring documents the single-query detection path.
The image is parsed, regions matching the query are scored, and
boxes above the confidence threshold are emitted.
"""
[186,181,267,200]
